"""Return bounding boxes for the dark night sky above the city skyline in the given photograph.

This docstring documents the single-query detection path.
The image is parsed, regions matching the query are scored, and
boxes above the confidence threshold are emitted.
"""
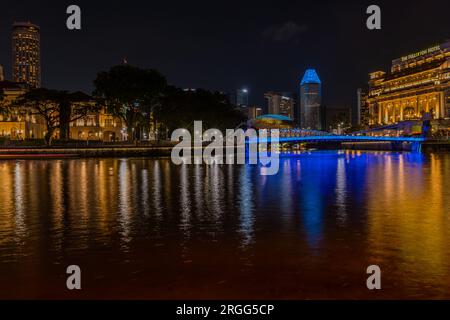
[0,0,450,107]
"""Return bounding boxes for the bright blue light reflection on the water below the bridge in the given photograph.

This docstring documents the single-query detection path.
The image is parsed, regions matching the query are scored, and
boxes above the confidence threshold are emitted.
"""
[255,151,426,249]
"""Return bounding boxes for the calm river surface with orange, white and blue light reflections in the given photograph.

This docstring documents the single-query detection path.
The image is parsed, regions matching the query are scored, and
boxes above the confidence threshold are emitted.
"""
[0,151,450,299]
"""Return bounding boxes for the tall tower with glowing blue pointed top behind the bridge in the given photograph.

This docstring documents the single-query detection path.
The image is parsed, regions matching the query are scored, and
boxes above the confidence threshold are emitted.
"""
[300,69,325,130]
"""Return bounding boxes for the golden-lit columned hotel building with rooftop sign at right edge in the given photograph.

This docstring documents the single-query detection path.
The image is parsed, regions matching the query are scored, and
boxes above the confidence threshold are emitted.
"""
[368,41,450,125]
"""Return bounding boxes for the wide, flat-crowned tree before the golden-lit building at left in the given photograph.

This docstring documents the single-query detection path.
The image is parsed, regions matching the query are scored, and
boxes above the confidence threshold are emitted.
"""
[15,88,98,146]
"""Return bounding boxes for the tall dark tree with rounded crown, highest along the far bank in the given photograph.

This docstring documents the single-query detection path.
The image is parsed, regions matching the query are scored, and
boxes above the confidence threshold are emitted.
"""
[94,64,167,141]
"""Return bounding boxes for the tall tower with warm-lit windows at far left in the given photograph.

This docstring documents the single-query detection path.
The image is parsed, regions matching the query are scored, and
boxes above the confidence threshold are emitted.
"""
[12,22,41,88]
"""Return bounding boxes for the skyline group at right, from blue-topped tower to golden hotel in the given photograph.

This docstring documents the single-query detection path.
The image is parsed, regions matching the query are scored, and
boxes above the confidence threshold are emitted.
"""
[244,41,450,130]
